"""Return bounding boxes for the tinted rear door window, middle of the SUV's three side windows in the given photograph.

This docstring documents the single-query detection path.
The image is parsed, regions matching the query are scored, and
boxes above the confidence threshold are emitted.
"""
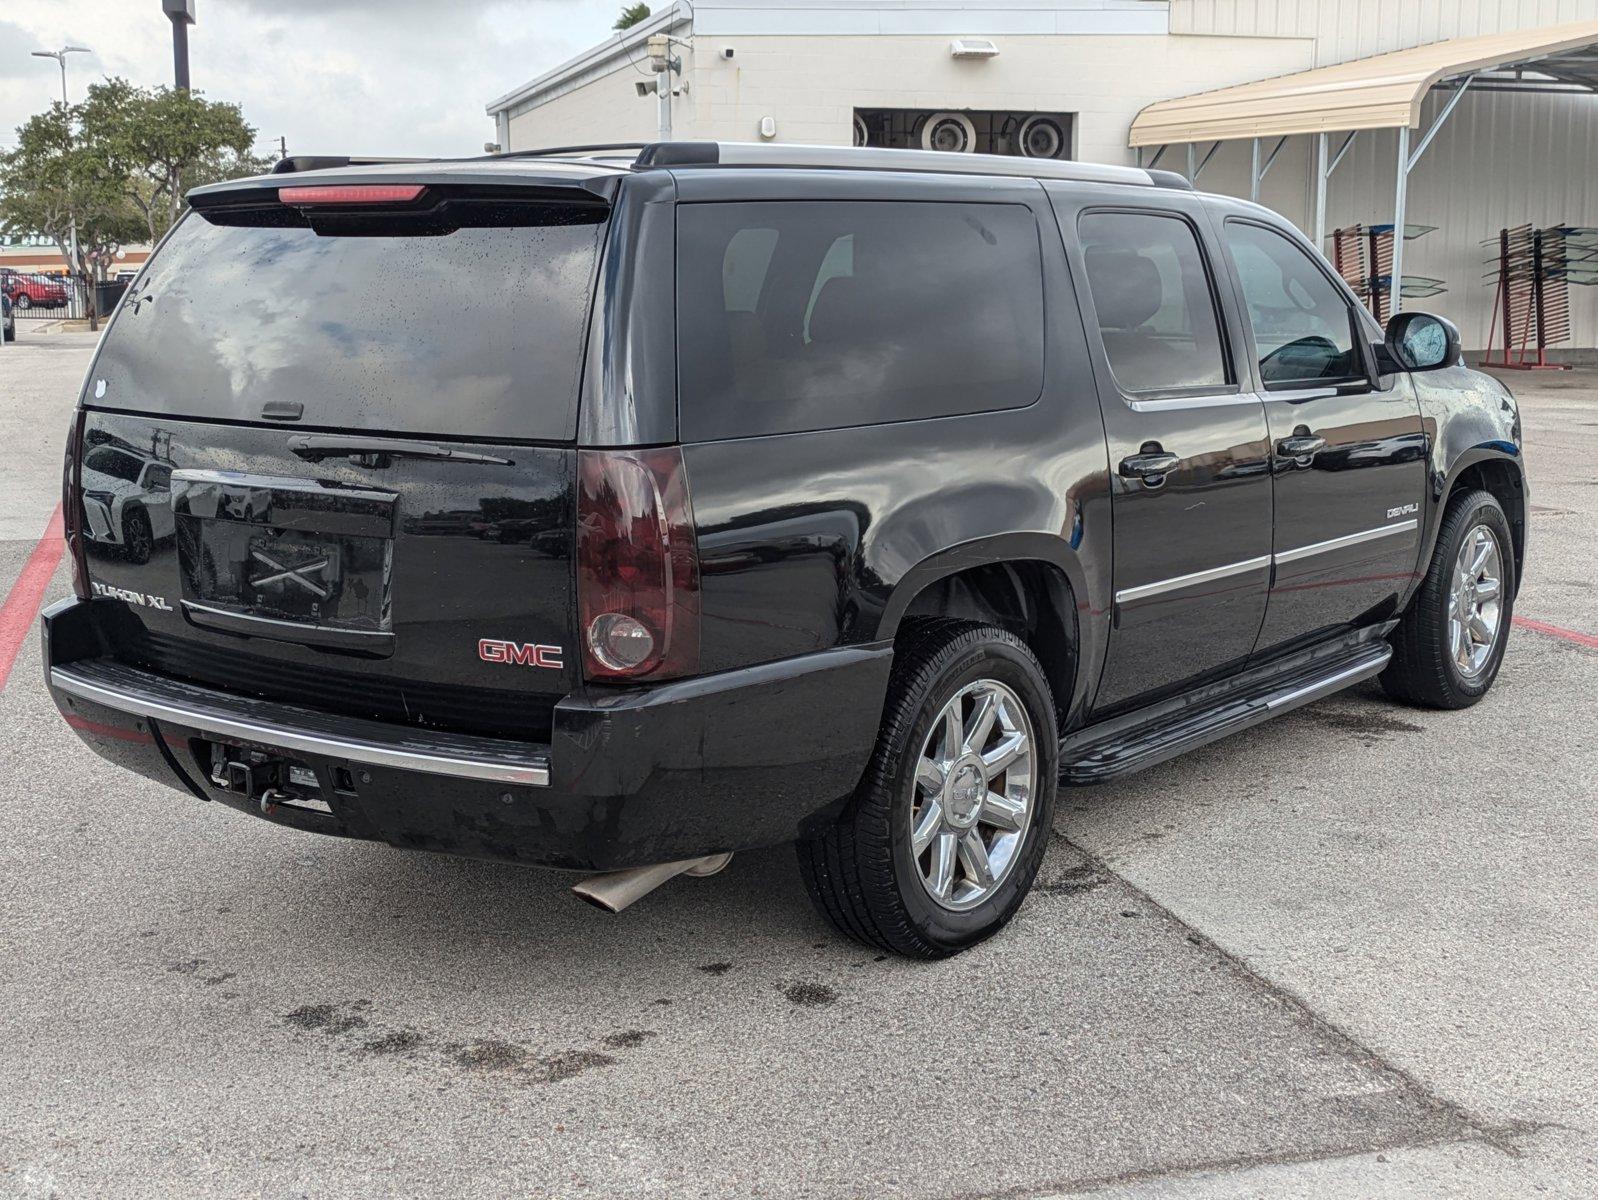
[1077,213,1227,391]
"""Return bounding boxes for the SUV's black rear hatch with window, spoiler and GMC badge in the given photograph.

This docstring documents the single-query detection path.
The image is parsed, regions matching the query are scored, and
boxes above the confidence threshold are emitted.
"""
[78,165,614,740]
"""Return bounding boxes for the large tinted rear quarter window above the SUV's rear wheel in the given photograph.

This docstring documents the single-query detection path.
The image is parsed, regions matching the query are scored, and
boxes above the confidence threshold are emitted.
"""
[678,200,1043,441]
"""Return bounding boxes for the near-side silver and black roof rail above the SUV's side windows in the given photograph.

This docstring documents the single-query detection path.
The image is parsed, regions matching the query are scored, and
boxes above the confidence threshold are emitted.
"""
[636,142,1192,192]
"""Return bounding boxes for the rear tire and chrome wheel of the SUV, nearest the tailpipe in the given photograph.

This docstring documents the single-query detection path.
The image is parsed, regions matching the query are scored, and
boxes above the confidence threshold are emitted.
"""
[797,618,1059,959]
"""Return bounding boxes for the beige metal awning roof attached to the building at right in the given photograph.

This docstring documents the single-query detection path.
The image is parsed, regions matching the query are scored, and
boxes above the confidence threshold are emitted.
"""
[1128,21,1598,145]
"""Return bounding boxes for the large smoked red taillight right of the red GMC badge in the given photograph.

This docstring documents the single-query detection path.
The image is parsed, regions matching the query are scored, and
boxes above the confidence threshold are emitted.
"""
[577,447,700,679]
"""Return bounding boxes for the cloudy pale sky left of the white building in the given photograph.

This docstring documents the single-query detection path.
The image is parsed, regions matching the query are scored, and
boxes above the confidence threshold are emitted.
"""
[0,0,622,155]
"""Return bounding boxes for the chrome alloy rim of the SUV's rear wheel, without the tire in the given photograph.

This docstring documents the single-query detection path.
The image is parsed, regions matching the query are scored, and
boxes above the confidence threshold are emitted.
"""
[909,679,1037,912]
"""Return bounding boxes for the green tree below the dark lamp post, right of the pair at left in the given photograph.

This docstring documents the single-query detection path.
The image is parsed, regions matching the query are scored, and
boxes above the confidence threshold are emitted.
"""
[75,78,258,243]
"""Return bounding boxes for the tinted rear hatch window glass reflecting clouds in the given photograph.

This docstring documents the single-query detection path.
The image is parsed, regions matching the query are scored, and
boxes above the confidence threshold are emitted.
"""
[91,208,604,441]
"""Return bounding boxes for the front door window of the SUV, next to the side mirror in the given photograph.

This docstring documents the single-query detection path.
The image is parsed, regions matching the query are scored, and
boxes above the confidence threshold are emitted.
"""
[1226,221,1365,387]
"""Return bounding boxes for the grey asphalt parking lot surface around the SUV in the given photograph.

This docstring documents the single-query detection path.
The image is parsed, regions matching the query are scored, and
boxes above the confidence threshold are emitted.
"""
[0,329,1598,1200]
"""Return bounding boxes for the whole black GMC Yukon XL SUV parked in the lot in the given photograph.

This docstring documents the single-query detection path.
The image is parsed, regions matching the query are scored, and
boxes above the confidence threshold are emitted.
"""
[45,142,1528,957]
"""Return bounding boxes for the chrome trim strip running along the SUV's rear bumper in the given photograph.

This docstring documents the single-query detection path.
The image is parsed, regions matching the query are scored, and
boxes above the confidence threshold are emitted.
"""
[50,666,550,788]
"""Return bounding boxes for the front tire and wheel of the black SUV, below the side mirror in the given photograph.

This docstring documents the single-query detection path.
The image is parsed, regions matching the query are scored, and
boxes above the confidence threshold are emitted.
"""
[1381,489,1517,708]
